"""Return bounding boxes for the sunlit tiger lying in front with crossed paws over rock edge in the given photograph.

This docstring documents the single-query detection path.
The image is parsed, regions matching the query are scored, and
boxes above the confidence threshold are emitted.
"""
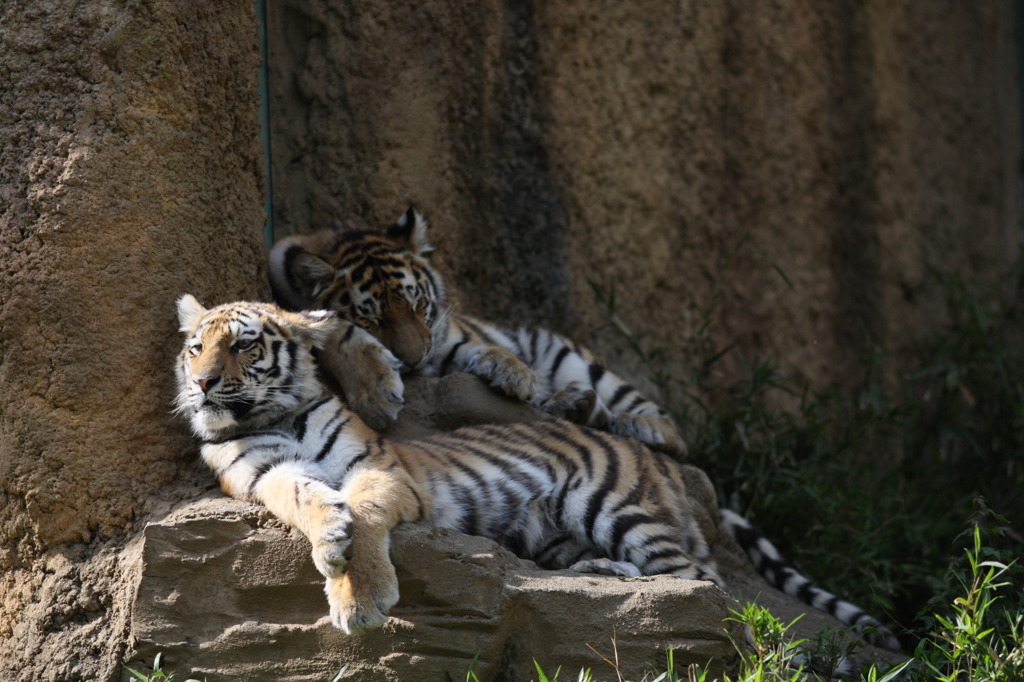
[175,294,899,650]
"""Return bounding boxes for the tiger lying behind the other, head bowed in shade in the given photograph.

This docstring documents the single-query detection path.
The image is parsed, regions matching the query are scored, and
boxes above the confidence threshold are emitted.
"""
[269,208,686,457]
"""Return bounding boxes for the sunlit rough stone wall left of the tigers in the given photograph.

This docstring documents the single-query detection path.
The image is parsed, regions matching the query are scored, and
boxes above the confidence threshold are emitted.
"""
[0,0,264,680]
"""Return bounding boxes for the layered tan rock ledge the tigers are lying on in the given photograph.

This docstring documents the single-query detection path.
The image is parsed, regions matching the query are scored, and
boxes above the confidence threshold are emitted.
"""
[122,375,905,682]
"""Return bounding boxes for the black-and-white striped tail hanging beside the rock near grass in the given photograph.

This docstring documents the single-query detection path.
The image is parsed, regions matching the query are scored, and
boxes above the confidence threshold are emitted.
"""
[720,509,900,651]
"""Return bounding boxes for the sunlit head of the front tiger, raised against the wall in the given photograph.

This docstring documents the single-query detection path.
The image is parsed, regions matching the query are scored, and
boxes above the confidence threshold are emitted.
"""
[177,294,337,438]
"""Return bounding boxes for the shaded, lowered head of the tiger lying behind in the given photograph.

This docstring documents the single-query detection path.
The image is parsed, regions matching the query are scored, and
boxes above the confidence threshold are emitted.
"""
[270,209,447,372]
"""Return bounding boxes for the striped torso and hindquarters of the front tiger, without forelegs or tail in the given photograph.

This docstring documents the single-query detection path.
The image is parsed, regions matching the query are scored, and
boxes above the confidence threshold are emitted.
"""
[395,421,719,582]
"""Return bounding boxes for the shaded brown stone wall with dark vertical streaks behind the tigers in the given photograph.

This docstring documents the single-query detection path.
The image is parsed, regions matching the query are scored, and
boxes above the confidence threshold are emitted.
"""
[269,0,1021,395]
